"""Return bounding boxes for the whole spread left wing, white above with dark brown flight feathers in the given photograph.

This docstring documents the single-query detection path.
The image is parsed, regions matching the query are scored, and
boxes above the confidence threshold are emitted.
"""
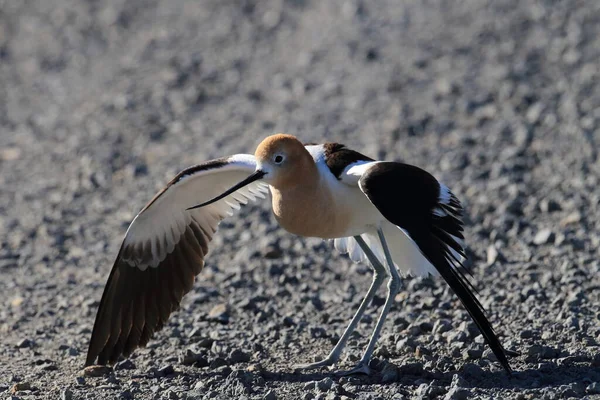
[86,154,268,365]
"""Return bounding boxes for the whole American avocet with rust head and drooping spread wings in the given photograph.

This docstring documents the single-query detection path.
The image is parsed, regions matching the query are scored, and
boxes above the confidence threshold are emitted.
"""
[86,134,510,373]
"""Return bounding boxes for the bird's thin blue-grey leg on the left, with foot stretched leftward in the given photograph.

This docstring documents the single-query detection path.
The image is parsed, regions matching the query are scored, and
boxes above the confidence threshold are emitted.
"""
[294,236,386,370]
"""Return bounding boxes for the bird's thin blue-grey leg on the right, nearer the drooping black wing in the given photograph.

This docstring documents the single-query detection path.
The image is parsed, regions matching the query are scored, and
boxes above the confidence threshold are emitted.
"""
[340,228,400,375]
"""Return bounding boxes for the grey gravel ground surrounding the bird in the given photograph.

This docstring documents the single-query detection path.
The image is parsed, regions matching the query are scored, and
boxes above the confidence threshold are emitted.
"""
[0,0,600,400]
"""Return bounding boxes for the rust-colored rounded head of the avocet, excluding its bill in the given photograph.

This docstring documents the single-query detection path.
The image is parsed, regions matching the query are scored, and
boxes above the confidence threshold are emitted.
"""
[254,133,316,188]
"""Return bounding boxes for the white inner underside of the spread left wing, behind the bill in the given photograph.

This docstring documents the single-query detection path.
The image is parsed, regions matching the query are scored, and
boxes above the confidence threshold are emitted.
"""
[122,155,269,271]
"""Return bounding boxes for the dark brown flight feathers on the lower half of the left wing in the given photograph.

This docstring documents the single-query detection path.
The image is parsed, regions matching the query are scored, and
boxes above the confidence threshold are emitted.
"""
[86,222,209,365]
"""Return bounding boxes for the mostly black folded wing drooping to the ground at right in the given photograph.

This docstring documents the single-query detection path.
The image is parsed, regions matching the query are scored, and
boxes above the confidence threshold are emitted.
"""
[345,162,510,372]
